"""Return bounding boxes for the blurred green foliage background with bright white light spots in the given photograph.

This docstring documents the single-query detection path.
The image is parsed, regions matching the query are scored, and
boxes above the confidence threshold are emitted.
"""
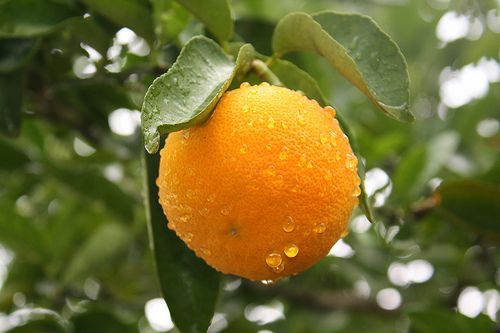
[0,0,500,333]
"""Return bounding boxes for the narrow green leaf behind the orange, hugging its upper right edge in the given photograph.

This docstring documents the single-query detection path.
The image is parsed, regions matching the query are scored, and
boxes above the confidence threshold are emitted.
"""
[269,59,374,222]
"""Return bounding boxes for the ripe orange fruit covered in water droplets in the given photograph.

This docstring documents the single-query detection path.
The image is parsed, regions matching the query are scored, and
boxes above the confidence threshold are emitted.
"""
[157,83,360,280]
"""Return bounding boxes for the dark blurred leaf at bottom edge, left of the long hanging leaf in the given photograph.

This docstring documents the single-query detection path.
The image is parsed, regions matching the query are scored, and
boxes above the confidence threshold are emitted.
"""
[71,309,137,333]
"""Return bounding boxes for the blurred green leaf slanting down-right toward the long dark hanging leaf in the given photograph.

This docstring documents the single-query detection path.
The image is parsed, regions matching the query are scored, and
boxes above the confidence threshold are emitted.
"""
[46,163,136,223]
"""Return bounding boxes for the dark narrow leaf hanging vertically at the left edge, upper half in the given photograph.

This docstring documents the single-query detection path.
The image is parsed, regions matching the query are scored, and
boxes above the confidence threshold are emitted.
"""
[0,69,24,136]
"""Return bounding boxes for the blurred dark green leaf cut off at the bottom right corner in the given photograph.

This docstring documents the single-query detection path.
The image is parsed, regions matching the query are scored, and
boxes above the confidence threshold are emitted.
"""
[410,309,495,333]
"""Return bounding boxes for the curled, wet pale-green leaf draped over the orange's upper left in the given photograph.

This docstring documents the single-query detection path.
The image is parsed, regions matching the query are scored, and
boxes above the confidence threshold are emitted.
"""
[141,36,254,153]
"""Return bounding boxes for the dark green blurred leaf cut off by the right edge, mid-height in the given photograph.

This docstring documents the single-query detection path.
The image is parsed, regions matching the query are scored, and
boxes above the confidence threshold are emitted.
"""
[437,179,500,236]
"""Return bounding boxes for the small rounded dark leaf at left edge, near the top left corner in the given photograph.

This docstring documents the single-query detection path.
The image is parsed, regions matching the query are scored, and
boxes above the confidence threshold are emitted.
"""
[0,38,38,73]
